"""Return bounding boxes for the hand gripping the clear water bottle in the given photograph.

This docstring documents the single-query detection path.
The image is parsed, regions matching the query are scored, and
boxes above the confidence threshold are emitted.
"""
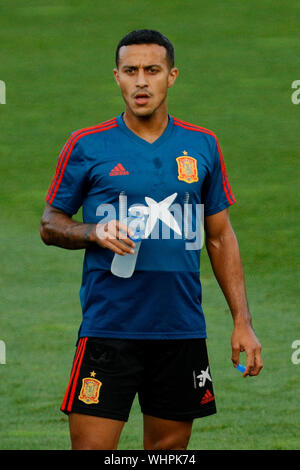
[91,220,135,256]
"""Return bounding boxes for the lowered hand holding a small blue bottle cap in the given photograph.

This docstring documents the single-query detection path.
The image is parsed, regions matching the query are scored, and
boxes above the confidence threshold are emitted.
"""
[231,324,263,377]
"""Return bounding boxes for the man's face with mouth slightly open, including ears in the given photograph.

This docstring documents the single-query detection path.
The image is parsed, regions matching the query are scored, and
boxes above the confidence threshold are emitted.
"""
[114,44,178,117]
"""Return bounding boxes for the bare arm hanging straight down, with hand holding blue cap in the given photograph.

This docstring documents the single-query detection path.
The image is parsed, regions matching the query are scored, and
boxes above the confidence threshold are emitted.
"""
[205,209,262,377]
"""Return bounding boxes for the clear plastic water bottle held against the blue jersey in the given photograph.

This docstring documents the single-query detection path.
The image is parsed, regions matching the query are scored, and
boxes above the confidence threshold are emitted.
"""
[111,214,145,277]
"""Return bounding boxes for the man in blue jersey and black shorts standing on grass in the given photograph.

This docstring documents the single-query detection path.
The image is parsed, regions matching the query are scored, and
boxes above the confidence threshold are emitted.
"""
[41,30,262,450]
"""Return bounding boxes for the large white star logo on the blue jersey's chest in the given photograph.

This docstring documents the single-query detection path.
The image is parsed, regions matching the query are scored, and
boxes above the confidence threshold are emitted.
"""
[134,193,181,238]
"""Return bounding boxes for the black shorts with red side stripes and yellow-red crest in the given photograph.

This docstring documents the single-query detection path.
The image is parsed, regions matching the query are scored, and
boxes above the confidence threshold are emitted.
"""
[61,338,216,421]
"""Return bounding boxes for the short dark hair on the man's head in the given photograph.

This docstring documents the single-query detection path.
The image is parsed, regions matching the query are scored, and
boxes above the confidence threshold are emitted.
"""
[115,29,175,68]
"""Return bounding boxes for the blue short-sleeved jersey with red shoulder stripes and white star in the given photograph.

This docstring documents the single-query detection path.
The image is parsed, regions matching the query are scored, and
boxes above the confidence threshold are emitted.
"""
[46,114,235,339]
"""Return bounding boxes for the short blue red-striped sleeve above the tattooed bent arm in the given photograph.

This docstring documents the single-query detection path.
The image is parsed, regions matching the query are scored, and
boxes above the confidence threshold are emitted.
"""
[45,134,87,215]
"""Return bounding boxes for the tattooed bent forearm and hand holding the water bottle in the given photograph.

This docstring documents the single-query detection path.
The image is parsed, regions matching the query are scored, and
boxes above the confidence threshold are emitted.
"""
[40,203,135,255]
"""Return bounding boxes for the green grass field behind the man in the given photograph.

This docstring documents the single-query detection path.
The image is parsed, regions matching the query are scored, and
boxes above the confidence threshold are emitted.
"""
[0,0,300,450]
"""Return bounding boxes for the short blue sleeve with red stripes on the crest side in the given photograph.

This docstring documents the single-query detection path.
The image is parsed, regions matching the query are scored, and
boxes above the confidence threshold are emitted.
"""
[202,139,236,216]
